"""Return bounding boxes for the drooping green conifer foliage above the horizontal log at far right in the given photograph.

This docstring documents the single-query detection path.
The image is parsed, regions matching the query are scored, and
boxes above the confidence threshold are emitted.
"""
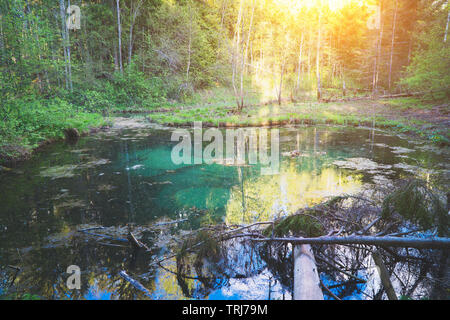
[381,179,449,236]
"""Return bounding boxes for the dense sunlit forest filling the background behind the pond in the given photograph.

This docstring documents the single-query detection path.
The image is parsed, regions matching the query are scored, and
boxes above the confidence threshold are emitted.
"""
[0,0,450,160]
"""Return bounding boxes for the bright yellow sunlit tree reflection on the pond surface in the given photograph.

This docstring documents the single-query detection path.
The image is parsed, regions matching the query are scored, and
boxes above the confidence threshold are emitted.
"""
[225,164,362,225]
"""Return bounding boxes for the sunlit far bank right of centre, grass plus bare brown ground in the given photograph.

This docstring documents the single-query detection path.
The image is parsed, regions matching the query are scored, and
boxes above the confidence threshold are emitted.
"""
[147,94,450,145]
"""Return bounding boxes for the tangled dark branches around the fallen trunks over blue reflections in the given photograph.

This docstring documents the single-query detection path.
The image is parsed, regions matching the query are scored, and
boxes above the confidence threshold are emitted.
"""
[172,181,449,299]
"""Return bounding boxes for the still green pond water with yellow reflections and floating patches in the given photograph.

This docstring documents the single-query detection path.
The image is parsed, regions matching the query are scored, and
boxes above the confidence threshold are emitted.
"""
[0,122,450,299]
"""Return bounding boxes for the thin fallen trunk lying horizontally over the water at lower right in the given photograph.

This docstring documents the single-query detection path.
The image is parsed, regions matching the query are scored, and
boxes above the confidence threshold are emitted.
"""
[251,236,450,249]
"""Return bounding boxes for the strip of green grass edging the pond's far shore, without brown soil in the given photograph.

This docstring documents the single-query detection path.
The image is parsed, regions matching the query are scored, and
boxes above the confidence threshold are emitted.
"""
[149,98,449,144]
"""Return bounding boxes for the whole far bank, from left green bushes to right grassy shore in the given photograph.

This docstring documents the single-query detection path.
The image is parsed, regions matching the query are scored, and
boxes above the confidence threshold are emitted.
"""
[0,88,450,165]
